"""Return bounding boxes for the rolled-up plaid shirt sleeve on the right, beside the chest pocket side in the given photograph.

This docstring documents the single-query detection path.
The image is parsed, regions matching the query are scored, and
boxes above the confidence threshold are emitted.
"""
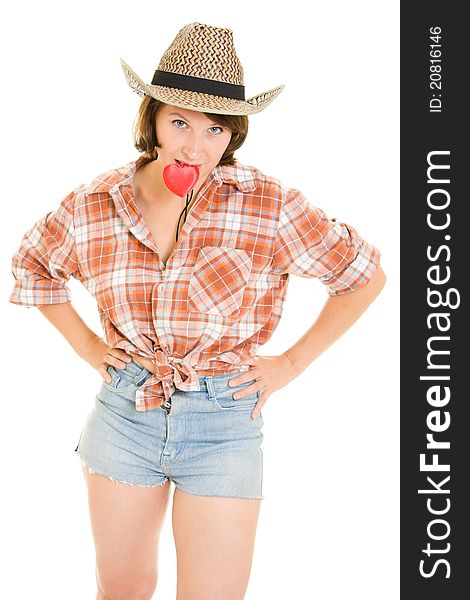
[272,189,380,296]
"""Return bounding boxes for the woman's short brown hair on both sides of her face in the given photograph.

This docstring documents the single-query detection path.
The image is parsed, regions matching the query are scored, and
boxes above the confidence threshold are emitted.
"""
[133,95,248,165]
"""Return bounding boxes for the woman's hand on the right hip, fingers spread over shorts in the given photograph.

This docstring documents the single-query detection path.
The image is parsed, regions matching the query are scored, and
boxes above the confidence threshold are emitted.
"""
[228,354,300,419]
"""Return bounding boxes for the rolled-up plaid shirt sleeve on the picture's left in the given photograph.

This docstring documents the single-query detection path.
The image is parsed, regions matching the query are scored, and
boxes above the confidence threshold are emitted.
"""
[9,188,80,307]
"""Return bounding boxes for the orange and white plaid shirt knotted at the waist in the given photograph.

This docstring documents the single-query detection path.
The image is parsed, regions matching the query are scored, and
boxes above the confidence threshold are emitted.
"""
[9,156,380,411]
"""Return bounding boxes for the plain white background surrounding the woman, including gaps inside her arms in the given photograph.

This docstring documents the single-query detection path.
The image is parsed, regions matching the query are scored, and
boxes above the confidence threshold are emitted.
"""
[0,0,399,600]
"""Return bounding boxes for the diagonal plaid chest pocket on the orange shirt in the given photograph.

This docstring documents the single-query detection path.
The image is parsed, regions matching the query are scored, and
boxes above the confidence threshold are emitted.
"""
[188,246,252,317]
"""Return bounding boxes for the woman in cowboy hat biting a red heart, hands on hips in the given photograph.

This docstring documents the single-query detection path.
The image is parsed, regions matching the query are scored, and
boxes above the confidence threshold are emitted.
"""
[10,23,385,600]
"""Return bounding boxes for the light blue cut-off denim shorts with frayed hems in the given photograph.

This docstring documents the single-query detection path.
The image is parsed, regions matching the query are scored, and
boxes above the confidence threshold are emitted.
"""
[75,360,264,500]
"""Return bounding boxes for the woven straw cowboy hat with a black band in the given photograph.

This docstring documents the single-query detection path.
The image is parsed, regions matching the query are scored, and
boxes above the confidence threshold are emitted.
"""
[120,23,285,115]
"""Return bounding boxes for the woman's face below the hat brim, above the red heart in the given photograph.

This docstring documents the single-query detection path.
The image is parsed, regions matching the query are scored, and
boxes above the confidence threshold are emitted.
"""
[156,104,232,180]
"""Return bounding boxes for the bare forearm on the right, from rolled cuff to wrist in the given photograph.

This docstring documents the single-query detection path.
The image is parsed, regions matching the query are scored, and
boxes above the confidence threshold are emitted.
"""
[284,266,386,373]
